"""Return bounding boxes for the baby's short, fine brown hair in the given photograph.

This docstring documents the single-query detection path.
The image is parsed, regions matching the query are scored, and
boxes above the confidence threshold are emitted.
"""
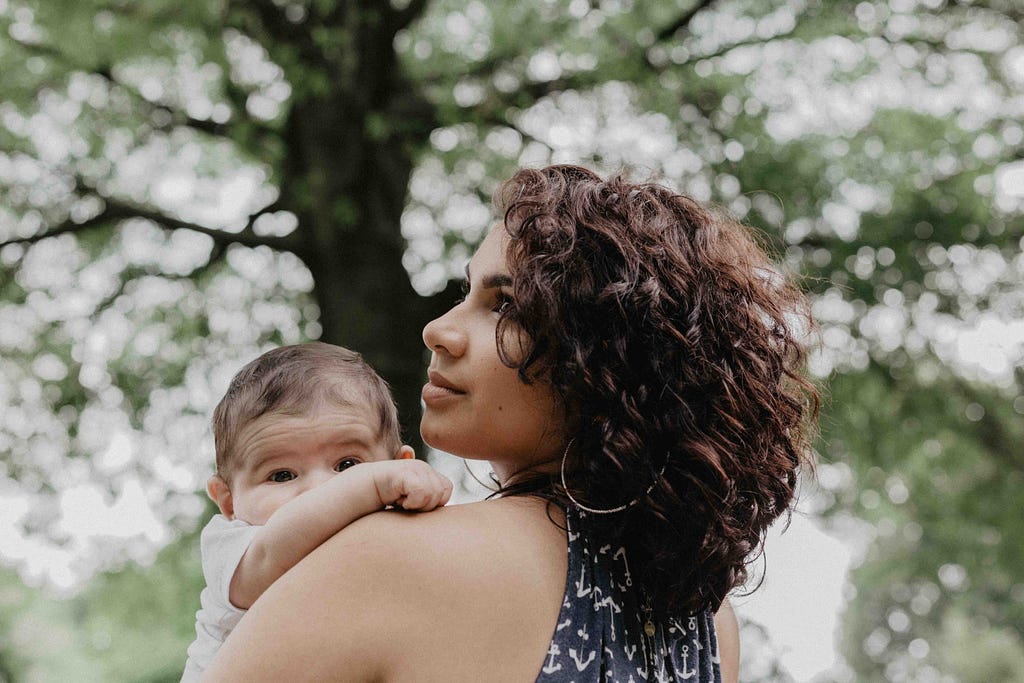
[213,342,401,479]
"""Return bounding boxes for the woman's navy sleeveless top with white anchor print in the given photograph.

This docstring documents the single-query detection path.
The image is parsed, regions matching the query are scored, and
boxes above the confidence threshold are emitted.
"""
[537,505,722,683]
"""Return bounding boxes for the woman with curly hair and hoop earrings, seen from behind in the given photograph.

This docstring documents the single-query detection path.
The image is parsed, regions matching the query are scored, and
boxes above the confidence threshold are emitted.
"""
[210,166,816,683]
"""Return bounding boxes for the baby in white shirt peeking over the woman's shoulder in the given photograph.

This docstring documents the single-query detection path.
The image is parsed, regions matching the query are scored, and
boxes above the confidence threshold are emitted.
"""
[182,342,452,681]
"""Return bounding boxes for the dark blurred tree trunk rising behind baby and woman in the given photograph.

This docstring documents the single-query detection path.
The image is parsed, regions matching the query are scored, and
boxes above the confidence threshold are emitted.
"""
[270,5,454,457]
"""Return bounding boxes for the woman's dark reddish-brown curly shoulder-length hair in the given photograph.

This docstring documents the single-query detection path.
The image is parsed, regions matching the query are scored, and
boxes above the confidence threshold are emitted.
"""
[495,166,818,614]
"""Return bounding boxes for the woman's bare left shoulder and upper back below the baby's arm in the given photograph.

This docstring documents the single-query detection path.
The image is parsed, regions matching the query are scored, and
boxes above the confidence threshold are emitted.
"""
[211,499,566,681]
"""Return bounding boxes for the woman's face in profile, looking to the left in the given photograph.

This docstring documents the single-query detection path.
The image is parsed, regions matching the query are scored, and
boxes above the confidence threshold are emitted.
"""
[420,225,565,482]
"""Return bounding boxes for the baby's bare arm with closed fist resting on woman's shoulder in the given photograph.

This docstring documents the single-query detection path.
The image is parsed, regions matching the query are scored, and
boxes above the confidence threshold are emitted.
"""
[228,460,452,609]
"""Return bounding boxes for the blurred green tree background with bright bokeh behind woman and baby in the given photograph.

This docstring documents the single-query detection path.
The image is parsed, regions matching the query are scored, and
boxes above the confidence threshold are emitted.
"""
[0,0,1024,682]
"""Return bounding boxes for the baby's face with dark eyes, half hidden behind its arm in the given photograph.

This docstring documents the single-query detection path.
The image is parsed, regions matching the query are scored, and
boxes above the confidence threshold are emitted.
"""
[223,405,395,524]
